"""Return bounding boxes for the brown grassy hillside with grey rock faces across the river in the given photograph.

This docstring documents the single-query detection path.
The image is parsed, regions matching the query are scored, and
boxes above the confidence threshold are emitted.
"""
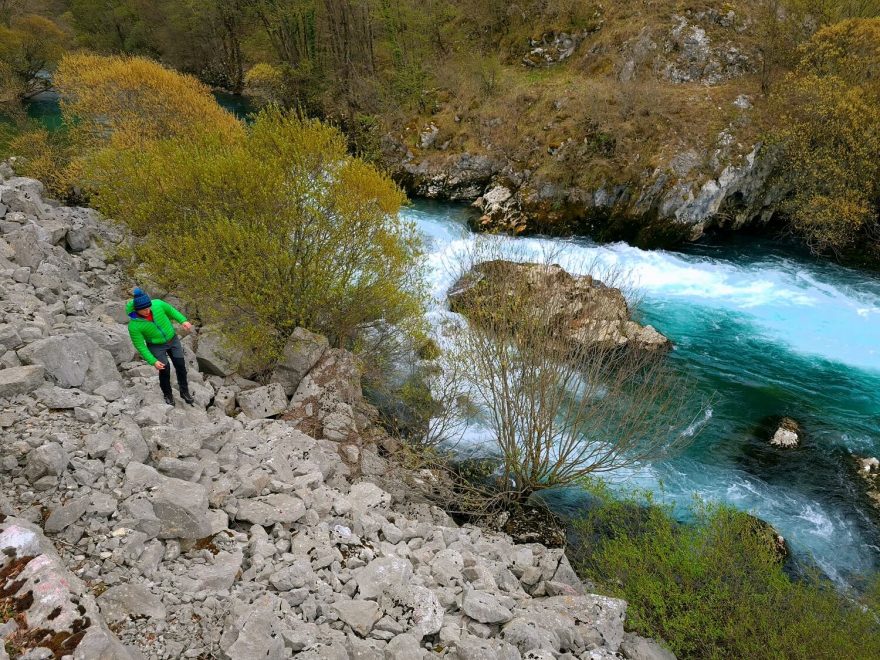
[383,2,785,245]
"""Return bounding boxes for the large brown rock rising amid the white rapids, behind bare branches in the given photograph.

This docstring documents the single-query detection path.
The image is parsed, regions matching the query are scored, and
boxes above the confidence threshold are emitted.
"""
[449,260,671,351]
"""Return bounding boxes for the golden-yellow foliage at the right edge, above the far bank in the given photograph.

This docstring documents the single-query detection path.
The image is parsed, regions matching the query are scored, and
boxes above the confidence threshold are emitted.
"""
[776,18,880,251]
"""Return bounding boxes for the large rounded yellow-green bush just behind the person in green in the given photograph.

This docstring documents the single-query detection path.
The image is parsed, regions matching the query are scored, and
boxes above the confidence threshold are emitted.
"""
[87,109,420,366]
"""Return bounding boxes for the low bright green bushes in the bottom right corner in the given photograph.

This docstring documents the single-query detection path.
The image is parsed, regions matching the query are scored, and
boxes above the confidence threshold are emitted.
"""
[576,495,880,660]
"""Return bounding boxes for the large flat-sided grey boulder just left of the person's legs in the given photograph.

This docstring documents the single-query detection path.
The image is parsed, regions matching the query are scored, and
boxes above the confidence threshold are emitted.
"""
[18,333,121,392]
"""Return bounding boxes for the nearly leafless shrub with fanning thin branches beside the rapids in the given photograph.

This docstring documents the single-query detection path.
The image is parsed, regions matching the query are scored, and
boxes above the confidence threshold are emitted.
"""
[449,246,687,502]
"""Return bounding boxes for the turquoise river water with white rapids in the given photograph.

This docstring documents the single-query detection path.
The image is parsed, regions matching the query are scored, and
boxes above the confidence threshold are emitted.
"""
[407,203,880,582]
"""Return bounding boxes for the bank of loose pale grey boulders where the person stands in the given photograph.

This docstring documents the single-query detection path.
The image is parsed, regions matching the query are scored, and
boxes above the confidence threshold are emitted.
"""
[0,164,669,660]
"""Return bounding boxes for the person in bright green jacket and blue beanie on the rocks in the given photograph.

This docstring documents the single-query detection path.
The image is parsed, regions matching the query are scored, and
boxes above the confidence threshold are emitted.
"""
[125,289,193,406]
